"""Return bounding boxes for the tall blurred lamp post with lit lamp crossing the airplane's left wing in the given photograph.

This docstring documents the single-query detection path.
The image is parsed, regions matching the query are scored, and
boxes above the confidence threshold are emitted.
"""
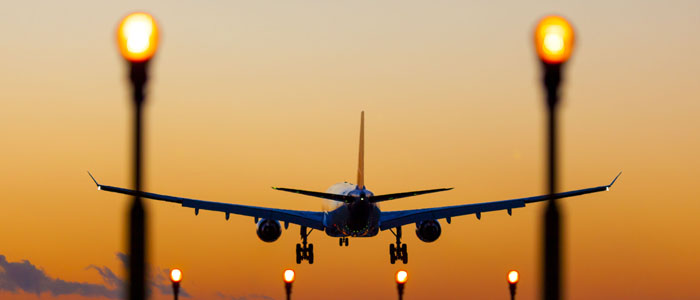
[117,12,158,300]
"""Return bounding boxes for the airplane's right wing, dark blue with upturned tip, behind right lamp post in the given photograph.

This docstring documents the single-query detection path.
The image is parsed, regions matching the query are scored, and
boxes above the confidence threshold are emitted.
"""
[379,173,622,230]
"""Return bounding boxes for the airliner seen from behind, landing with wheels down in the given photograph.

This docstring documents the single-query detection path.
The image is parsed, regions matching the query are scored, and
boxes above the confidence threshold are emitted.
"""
[88,111,622,264]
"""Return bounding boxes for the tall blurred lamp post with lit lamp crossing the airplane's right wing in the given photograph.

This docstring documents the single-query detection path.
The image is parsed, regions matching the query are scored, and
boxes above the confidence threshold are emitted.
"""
[534,16,574,300]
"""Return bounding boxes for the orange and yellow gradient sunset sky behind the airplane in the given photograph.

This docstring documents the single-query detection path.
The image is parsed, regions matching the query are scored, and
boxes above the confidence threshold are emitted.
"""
[0,0,700,300]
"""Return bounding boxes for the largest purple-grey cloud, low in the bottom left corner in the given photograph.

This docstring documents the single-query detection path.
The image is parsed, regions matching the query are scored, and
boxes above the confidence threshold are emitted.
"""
[0,255,121,299]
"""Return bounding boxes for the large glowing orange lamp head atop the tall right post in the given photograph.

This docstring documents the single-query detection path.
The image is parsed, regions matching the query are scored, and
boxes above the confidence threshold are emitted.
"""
[535,16,574,64]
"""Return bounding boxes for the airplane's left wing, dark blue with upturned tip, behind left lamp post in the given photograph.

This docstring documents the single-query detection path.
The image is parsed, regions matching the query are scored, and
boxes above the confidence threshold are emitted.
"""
[88,172,325,230]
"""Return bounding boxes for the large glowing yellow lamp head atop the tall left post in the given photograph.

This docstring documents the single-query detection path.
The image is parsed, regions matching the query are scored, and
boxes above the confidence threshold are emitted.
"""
[117,12,158,62]
